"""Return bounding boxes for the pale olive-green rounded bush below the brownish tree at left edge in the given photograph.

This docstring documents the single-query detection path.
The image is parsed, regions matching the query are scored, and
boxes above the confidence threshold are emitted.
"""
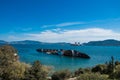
[2,61,29,80]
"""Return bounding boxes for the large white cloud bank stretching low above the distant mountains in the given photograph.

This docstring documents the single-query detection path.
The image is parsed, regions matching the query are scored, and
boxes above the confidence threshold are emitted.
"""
[21,28,120,42]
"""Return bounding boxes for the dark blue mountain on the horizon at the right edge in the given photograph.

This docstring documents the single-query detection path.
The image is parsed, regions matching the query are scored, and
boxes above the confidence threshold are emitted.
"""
[82,39,120,46]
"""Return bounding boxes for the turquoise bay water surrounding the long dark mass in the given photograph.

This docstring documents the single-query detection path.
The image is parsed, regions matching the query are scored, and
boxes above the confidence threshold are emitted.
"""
[13,44,120,70]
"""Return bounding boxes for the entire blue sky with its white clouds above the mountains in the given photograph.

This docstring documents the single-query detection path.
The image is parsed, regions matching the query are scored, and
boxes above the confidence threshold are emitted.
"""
[0,0,120,42]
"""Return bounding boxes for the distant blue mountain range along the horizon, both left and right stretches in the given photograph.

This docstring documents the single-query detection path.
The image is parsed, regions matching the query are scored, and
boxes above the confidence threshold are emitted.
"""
[0,39,120,46]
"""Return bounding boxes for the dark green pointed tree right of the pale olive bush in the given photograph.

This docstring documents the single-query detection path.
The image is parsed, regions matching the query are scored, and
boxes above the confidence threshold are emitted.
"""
[25,61,47,80]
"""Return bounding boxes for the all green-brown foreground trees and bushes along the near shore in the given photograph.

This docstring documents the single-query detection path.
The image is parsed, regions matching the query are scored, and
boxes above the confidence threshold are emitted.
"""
[0,45,120,80]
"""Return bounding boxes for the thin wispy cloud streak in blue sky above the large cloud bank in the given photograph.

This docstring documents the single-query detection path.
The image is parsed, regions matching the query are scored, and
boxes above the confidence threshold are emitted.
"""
[42,22,84,28]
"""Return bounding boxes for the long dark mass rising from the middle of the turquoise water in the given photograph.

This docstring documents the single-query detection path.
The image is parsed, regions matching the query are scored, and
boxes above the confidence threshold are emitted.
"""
[37,49,90,59]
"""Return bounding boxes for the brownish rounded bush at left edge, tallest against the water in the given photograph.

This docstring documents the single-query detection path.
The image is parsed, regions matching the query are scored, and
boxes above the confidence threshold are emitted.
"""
[0,45,18,66]
